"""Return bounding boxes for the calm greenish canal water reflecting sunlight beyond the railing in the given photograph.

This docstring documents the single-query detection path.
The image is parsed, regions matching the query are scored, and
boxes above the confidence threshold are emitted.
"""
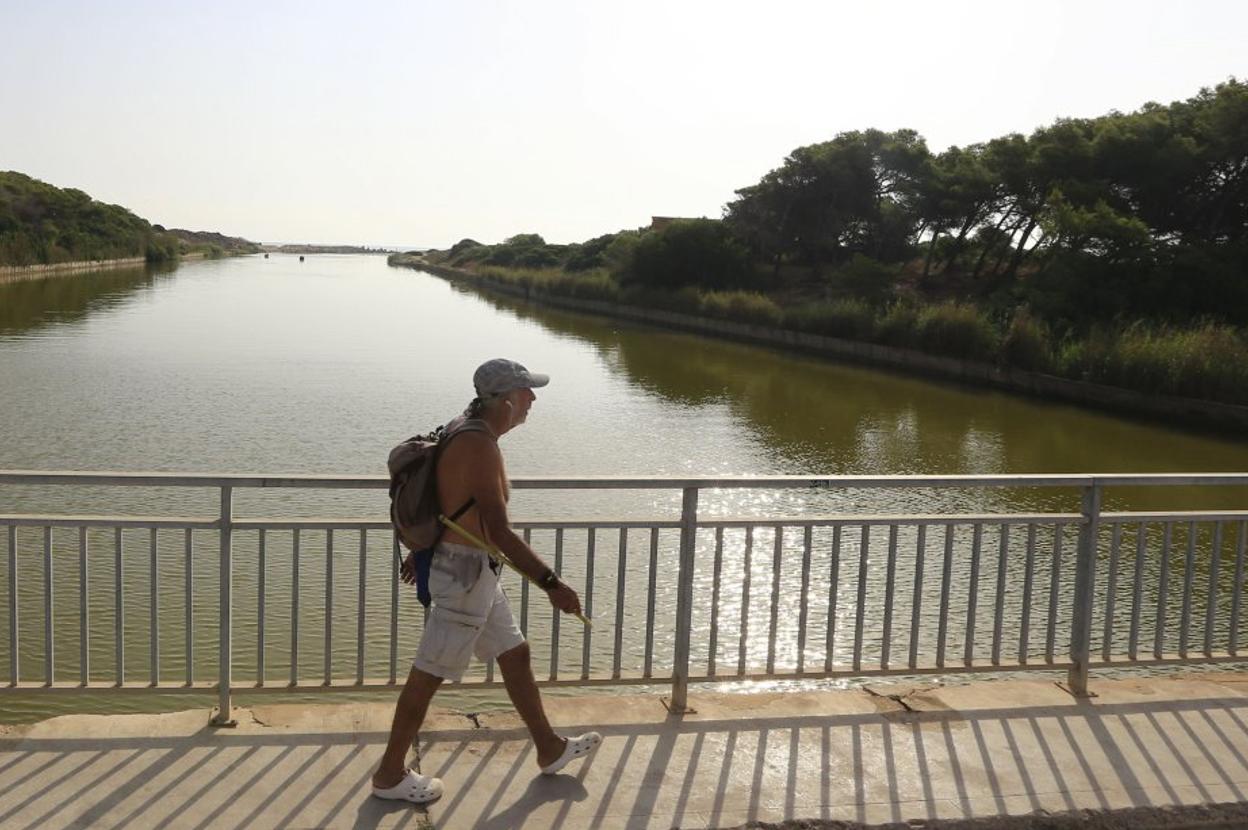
[0,255,1248,720]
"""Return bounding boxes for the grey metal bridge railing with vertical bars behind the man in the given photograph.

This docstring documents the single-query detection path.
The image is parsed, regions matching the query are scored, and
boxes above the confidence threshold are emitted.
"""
[0,472,1248,723]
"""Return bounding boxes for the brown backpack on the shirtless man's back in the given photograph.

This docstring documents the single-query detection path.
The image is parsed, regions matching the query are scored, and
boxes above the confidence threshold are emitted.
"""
[386,418,492,553]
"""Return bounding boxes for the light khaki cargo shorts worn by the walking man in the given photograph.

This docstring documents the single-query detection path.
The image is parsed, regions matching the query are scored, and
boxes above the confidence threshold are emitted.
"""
[412,542,524,680]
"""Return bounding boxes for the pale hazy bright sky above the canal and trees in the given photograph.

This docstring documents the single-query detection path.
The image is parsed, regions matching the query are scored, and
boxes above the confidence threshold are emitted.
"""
[0,0,1248,246]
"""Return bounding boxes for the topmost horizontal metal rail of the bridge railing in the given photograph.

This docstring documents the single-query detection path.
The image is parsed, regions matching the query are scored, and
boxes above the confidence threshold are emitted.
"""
[0,469,1248,489]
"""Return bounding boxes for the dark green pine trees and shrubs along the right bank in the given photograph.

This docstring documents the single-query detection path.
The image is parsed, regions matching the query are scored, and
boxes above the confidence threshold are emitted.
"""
[433,79,1248,331]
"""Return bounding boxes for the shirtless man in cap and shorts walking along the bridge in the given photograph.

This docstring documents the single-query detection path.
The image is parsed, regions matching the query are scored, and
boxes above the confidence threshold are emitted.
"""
[373,358,602,804]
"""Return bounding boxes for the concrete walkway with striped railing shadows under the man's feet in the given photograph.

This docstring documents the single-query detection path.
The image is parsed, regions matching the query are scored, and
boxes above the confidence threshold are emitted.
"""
[0,674,1248,830]
